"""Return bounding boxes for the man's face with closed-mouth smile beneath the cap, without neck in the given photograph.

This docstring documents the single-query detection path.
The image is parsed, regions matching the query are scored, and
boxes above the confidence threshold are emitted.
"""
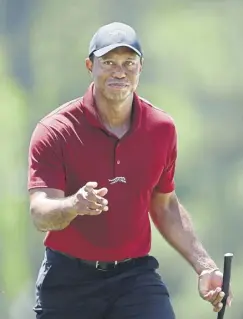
[86,47,142,101]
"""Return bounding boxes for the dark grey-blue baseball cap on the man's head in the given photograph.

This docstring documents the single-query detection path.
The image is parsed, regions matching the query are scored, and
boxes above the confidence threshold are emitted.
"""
[89,22,143,57]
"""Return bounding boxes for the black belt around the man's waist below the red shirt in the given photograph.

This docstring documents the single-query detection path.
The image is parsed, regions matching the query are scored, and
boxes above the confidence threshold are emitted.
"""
[48,248,134,271]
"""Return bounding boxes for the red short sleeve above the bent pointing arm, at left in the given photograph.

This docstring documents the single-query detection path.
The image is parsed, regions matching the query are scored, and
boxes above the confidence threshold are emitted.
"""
[27,123,65,191]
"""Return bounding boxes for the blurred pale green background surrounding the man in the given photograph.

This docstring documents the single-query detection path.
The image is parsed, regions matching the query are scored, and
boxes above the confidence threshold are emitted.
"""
[0,0,243,319]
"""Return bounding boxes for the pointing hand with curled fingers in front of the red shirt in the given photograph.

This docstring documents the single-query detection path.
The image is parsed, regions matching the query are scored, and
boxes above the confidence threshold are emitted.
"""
[72,182,108,215]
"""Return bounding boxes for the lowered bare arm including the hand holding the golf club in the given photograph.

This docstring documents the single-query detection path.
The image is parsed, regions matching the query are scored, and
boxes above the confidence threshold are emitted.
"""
[150,192,232,312]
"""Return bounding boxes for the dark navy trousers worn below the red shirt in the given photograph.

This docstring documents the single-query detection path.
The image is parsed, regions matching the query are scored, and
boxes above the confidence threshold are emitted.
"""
[34,248,175,319]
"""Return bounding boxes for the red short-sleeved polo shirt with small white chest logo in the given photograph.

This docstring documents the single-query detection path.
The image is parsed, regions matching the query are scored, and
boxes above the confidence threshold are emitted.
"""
[28,84,177,261]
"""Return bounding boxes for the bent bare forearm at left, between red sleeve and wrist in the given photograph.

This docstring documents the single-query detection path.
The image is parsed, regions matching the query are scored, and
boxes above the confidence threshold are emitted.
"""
[30,197,77,232]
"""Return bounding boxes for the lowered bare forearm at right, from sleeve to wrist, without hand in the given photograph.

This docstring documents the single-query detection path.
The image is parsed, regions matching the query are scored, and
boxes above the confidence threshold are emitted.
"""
[151,201,217,274]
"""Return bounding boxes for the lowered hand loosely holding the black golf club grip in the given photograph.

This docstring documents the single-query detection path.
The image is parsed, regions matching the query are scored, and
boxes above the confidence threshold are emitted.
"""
[198,270,232,312]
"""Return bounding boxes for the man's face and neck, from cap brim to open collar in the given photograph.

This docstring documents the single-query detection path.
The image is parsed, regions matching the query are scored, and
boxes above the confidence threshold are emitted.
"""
[86,47,143,138]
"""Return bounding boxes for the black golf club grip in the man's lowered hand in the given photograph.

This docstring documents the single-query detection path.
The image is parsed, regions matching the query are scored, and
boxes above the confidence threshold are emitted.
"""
[217,253,233,319]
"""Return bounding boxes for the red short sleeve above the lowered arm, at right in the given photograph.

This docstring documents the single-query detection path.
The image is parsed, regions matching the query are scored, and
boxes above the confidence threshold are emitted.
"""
[155,126,177,194]
